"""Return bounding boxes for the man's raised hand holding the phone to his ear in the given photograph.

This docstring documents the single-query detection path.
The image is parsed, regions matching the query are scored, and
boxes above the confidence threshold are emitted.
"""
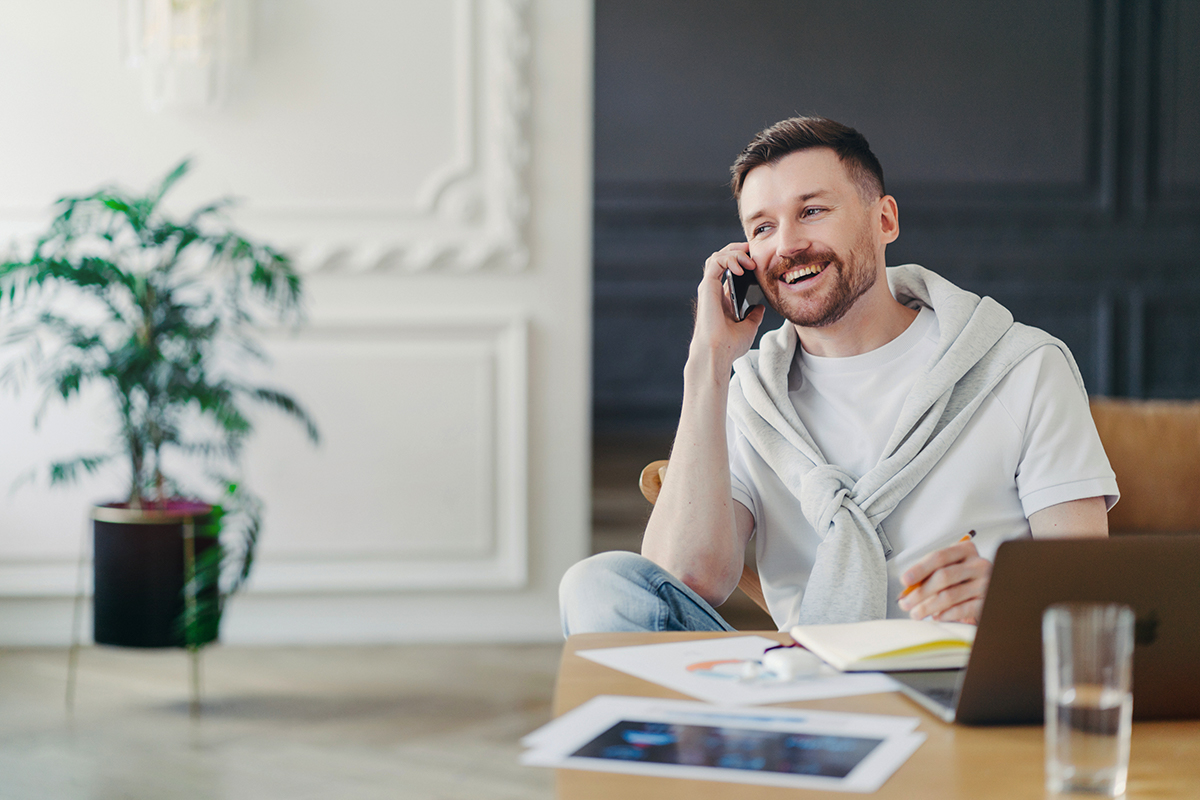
[691,242,764,366]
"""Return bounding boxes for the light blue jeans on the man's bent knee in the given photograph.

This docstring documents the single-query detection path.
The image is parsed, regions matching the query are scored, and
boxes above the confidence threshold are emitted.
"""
[558,551,734,637]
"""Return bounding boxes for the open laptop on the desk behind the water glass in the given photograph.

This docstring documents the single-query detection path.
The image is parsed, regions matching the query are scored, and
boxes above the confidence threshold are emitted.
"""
[889,535,1200,724]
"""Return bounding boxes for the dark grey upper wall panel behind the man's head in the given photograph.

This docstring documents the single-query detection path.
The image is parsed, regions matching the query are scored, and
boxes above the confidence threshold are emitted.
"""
[596,0,1118,219]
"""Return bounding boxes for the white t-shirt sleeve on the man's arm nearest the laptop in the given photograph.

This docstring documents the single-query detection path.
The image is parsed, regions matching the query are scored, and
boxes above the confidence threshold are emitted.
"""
[996,345,1120,517]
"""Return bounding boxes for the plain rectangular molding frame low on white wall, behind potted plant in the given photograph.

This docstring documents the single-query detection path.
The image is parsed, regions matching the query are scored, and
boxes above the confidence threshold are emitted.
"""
[0,313,529,599]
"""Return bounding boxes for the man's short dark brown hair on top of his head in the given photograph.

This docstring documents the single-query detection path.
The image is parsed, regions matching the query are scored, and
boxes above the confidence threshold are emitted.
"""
[730,116,887,200]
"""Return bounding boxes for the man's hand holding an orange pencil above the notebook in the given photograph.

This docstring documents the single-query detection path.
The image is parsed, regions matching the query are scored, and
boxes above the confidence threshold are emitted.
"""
[900,540,991,625]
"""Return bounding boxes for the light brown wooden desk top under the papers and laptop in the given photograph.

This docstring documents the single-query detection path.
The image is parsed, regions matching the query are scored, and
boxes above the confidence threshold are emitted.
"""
[554,631,1200,800]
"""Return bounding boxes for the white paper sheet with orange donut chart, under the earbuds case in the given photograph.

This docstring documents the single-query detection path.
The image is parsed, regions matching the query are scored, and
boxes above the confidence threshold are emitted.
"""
[577,636,899,705]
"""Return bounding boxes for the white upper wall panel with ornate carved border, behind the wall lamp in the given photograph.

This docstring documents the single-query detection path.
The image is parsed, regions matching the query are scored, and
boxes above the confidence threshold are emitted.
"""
[0,0,532,272]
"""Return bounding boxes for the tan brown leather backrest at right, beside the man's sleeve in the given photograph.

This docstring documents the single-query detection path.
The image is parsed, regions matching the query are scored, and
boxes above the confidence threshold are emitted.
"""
[1091,397,1200,534]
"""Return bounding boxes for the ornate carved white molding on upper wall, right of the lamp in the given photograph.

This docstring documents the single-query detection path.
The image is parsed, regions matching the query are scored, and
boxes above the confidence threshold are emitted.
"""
[277,0,533,272]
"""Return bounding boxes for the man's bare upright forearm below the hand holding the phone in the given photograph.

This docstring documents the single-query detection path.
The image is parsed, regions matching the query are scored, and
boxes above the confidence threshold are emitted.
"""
[642,347,744,604]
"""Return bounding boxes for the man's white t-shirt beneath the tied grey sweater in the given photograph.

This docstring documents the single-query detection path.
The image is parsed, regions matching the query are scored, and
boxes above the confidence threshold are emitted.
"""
[727,308,1117,631]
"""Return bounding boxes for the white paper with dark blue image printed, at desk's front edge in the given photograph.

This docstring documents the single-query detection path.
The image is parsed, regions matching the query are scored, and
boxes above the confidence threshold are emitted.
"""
[521,696,925,792]
